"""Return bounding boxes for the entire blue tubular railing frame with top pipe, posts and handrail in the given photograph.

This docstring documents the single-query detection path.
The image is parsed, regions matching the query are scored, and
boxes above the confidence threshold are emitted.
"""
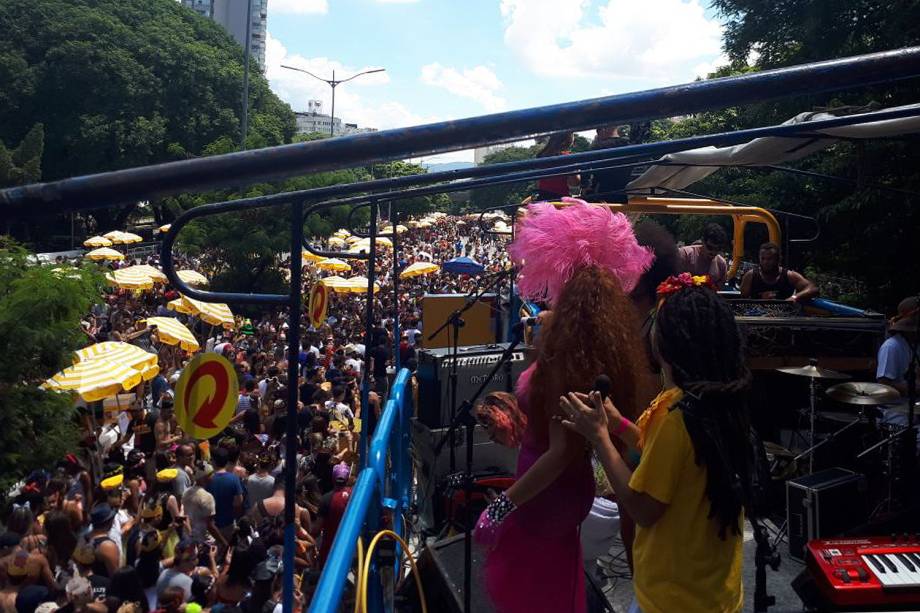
[0,47,920,613]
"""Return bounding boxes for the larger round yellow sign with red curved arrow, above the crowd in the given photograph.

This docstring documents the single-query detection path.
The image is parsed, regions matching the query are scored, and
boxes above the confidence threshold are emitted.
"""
[175,353,239,440]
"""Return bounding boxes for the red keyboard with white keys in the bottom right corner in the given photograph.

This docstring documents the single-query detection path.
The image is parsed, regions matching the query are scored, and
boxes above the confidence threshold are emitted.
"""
[807,534,920,607]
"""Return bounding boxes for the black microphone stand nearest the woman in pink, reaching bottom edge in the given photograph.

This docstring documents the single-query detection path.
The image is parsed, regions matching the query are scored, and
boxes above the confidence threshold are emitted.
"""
[434,325,523,613]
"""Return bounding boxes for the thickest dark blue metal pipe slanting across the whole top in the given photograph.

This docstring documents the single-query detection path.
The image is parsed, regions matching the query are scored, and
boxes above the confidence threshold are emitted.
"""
[0,47,920,214]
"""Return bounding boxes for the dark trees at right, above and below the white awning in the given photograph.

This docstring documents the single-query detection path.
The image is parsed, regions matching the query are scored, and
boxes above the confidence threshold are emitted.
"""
[651,0,920,312]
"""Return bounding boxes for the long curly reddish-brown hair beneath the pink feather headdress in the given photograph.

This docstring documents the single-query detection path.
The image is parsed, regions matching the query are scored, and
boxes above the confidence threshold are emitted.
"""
[529,266,645,436]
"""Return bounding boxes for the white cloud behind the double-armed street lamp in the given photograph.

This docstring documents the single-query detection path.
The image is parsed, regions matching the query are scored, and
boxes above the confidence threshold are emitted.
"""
[265,32,440,130]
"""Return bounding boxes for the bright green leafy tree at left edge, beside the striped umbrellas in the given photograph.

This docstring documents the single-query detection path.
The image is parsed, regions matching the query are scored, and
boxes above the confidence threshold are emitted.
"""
[0,237,103,491]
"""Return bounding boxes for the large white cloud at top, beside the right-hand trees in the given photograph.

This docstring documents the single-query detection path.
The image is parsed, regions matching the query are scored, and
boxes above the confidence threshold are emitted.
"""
[501,0,722,82]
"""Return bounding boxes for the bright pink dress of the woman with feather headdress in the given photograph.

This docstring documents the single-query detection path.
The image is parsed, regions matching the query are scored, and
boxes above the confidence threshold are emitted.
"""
[484,364,595,613]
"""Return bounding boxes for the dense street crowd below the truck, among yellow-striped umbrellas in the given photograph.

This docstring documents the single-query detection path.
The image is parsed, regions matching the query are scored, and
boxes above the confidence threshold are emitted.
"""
[0,218,507,613]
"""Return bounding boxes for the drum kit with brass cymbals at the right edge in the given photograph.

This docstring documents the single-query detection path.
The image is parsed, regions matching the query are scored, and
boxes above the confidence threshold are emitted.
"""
[770,359,913,512]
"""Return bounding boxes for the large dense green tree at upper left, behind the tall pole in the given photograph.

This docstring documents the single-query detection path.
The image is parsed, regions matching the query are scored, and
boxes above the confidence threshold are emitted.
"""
[0,0,295,237]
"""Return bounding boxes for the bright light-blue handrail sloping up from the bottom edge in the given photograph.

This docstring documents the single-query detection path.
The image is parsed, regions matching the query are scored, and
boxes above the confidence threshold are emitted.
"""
[309,369,412,613]
